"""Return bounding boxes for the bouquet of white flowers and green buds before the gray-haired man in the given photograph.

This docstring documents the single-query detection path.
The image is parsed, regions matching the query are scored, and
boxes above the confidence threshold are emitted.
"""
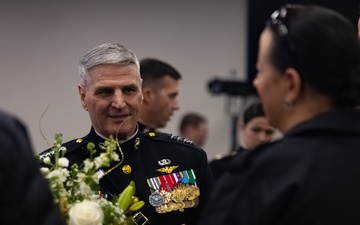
[41,134,145,225]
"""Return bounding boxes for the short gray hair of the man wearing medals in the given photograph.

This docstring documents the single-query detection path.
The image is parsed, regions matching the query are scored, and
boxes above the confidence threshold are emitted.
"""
[79,43,140,86]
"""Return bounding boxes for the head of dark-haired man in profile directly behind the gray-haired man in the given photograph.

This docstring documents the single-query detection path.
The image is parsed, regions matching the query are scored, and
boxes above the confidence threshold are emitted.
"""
[139,58,181,131]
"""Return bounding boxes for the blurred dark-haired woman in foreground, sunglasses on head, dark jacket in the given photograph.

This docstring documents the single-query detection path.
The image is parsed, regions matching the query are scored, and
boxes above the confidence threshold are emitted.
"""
[200,5,360,225]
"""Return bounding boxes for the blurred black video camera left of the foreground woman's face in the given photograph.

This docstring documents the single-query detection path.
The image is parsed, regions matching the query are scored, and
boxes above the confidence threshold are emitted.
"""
[208,78,257,96]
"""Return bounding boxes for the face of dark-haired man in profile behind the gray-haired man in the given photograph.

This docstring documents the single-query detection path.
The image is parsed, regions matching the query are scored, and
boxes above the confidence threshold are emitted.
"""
[149,76,179,128]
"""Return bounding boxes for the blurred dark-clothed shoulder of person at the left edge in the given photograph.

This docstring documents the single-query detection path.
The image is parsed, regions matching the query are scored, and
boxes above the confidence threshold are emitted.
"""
[0,112,64,225]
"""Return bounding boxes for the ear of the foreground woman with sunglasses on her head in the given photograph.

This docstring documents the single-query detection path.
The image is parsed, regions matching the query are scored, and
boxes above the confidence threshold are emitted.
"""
[283,68,302,102]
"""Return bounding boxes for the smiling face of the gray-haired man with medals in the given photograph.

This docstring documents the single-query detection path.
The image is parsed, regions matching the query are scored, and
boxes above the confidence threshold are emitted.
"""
[78,64,143,140]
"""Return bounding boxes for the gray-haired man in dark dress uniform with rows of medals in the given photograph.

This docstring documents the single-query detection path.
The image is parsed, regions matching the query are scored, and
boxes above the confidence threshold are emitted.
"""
[41,43,213,225]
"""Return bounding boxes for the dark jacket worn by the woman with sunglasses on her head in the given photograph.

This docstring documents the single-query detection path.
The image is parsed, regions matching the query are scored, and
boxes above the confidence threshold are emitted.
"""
[200,110,360,225]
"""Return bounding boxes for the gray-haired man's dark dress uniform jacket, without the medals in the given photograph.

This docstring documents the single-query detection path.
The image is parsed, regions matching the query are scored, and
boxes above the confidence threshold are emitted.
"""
[41,128,213,225]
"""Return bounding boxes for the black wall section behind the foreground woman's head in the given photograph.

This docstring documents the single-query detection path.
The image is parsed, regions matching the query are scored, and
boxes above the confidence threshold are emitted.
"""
[247,0,359,82]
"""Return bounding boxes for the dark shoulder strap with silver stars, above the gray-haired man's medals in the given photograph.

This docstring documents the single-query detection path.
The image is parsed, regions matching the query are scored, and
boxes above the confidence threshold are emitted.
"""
[144,132,204,152]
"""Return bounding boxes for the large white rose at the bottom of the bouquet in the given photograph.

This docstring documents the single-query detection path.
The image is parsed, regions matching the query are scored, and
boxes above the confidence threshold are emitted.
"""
[69,200,104,225]
